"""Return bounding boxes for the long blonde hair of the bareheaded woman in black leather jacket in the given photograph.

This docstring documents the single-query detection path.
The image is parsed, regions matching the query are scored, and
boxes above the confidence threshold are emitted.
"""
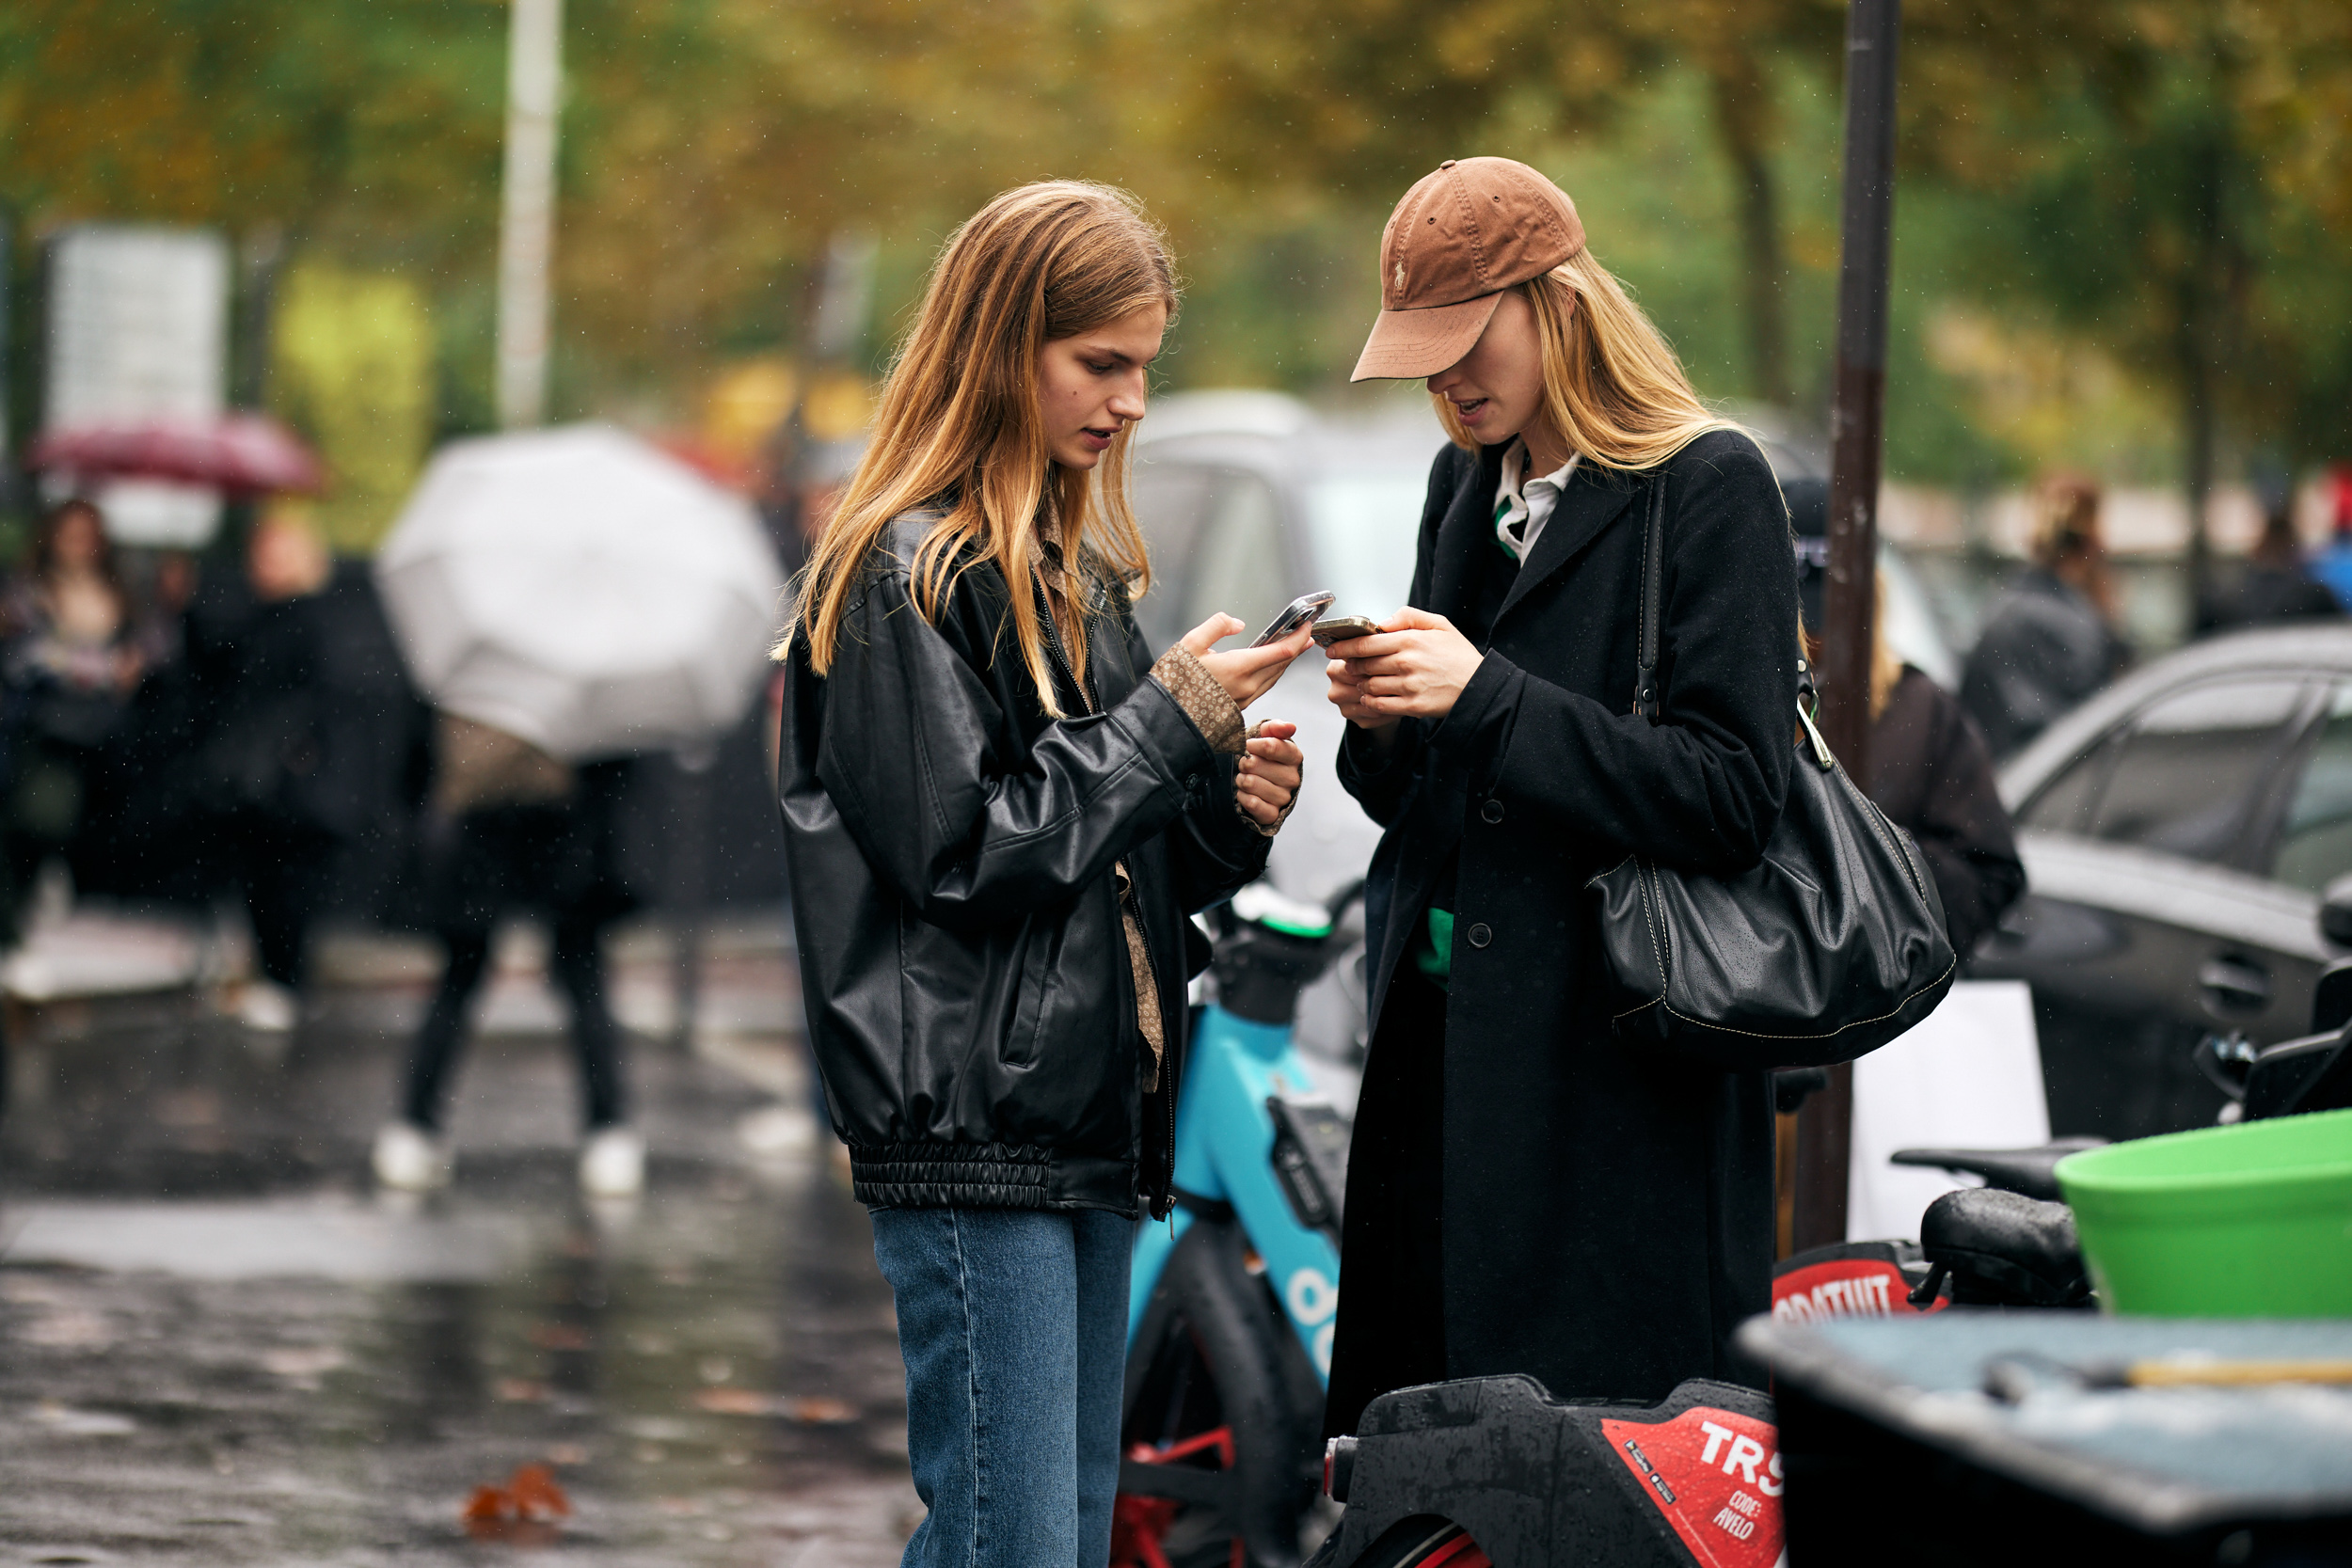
[779,179,1179,717]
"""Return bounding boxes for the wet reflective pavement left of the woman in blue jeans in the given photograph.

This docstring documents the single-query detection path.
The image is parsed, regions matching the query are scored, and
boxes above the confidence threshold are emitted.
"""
[0,931,920,1568]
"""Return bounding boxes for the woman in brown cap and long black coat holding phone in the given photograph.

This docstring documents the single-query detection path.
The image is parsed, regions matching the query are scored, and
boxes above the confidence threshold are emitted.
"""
[1327,157,1797,1432]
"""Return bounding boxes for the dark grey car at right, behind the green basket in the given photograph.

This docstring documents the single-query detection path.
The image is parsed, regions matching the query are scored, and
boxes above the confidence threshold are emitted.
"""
[1971,626,2352,1138]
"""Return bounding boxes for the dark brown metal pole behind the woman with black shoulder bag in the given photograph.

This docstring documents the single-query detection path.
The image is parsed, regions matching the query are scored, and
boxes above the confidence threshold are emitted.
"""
[1797,0,1903,1251]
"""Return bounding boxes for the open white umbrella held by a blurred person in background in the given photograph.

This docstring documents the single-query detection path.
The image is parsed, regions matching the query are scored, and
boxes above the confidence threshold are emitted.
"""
[376,425,784,762]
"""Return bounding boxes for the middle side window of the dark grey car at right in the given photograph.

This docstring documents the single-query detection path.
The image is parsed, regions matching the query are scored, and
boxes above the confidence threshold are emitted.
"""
[2089,677,2308,861]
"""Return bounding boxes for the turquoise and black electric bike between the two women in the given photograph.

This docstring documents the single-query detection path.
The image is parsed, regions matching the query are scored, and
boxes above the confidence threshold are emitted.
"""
[1110,881,1362,1568]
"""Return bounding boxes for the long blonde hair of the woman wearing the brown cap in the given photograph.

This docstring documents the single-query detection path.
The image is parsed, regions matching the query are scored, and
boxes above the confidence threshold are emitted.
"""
[1433,249,1739,470]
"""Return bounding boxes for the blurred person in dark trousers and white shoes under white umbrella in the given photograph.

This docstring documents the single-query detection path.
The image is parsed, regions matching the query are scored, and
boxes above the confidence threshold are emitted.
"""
[376,425,781,1195]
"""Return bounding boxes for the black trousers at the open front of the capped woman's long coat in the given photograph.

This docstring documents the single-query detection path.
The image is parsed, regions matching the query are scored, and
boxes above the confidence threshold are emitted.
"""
[1325,961,1447,1436]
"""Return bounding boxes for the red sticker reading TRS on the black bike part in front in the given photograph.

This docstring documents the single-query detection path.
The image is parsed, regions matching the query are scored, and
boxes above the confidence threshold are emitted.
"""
[1602,1406,1781,1568]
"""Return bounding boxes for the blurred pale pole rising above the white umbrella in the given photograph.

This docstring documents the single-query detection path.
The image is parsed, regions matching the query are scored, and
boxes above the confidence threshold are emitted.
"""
[499,0,564,430]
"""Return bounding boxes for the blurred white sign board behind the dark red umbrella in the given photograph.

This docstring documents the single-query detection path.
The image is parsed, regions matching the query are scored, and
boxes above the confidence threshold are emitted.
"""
[42,223,229,547]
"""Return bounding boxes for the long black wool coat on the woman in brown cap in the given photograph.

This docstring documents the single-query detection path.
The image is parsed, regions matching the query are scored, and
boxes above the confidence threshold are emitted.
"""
[1331,430,1797,1430]
